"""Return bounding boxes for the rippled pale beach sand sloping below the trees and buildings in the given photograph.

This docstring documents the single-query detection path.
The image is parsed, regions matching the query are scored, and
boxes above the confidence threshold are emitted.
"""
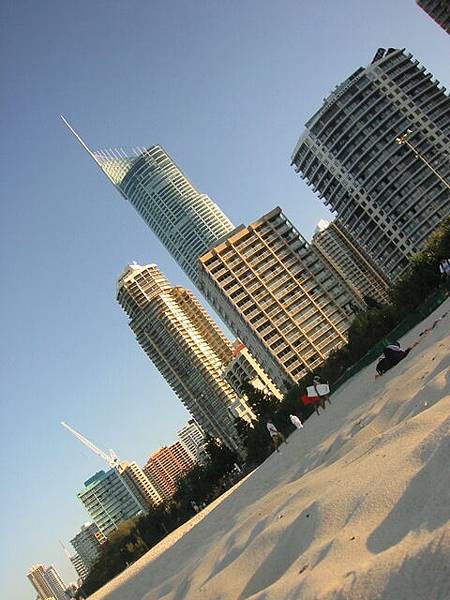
[91,300,450,600]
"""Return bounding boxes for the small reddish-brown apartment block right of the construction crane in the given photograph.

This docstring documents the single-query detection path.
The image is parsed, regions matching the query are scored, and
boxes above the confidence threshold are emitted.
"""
[144,442,194,499]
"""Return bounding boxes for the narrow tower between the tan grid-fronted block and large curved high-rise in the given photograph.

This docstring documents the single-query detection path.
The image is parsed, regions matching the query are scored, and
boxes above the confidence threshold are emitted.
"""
[311,219,389,304]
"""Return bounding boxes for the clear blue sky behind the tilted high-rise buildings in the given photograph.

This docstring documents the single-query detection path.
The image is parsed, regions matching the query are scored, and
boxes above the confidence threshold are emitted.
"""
[0,0,450,600]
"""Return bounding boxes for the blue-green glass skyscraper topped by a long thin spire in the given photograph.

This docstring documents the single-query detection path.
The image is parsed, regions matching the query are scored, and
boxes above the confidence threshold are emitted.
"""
[61,117,234,285]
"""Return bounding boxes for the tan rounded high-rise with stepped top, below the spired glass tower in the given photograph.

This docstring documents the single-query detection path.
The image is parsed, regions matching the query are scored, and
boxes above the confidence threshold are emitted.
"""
[117,264,244,448]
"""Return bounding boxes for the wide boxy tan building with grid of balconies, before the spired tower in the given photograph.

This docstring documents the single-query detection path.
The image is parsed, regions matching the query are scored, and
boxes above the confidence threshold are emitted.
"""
[199,208,356,392]
